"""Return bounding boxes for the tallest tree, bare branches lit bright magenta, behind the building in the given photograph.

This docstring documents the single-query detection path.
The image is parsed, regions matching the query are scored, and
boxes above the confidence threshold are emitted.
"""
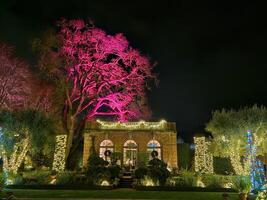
[34,20,155,169]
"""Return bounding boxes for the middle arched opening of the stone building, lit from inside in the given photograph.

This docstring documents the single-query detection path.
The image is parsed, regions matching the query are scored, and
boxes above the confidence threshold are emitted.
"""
[123,140,137,169]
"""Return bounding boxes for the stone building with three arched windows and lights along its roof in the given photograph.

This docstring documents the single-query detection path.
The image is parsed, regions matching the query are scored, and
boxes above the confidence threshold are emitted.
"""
[83,120,177,169]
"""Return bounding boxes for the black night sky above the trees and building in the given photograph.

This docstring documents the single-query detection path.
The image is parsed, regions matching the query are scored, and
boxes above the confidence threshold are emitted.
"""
[0,0,267,139]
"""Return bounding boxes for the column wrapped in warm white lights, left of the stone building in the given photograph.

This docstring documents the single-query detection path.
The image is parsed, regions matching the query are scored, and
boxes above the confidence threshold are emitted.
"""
[52,135,67,172]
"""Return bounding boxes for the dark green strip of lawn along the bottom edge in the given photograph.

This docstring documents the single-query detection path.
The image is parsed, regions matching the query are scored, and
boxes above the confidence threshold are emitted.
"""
[1,189,241,200]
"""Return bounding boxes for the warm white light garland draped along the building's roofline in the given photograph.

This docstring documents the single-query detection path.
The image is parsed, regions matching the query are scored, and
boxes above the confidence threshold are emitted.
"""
[97,120,167,130]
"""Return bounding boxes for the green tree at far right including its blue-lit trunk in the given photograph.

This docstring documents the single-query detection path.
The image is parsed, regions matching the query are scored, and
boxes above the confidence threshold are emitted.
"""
[206,105,267,189]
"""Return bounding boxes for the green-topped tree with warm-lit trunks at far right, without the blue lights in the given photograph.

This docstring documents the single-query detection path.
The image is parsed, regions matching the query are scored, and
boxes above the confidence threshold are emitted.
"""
[206,105,267,172]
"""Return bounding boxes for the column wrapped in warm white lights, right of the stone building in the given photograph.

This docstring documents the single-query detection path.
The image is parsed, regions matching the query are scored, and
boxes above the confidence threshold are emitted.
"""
[194,137,213,174]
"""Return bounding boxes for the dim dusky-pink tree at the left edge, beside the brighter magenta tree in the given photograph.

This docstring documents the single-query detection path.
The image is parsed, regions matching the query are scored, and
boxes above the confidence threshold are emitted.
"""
[0,44,52,112]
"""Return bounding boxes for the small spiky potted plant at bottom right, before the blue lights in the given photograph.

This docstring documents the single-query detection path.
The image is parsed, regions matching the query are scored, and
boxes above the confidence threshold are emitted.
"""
[234,176,251,200]
